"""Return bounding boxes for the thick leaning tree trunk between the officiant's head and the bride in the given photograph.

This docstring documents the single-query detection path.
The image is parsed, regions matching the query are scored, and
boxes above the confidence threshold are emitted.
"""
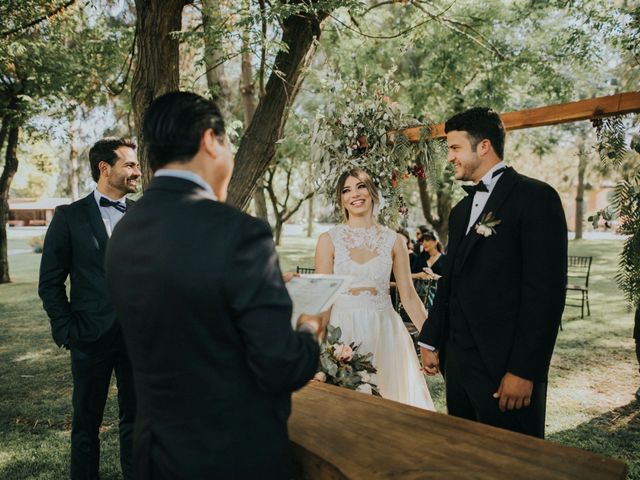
[229,7,326,209]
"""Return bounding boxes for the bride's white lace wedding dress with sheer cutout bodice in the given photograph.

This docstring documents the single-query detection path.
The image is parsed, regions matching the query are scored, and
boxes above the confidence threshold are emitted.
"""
[329,224,434,410]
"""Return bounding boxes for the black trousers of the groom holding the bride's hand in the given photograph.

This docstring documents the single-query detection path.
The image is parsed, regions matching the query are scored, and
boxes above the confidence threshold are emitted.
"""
[445,343,547,438]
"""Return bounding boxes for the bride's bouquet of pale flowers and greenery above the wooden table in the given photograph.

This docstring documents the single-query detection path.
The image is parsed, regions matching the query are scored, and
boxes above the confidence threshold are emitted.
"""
[314,325,381,396]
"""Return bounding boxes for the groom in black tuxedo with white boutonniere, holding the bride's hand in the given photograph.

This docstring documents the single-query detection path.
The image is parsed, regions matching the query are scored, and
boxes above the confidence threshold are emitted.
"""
[419,108,567,438]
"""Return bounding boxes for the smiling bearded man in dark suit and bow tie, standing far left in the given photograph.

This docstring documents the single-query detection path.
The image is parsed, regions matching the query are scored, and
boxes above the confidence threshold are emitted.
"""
[38,139,140,479]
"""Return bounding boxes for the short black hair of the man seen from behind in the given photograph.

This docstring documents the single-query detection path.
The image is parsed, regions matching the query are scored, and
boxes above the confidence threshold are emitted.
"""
[142,92,225,172]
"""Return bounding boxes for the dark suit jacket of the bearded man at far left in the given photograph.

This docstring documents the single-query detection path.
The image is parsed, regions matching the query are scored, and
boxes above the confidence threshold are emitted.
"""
[38,192,133,351]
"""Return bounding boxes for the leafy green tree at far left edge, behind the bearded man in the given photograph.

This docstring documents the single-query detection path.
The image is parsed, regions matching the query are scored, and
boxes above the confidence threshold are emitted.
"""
[0,0,127,282]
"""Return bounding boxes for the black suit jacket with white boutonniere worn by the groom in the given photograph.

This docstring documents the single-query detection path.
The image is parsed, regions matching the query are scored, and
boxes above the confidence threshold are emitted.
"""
[419,168,567,387]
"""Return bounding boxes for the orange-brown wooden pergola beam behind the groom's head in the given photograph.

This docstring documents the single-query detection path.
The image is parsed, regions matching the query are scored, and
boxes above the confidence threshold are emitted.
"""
[396,92,640,142]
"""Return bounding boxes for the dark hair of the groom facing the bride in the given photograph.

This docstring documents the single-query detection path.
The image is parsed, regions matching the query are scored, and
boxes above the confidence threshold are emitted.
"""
[444,107,505,159]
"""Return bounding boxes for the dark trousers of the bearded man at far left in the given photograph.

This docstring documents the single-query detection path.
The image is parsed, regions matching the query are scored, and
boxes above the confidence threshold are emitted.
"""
[71,334,136,480]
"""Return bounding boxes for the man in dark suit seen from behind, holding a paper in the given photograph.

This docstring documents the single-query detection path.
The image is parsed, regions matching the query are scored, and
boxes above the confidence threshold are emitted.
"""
[106,92,328,480]
